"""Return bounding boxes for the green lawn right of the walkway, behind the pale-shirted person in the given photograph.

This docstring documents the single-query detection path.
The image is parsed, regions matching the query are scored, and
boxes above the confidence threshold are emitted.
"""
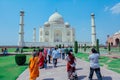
[75,53,120,73]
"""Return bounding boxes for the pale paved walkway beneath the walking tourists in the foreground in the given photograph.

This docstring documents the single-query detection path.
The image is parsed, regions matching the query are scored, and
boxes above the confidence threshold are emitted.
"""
[17,59,120,80]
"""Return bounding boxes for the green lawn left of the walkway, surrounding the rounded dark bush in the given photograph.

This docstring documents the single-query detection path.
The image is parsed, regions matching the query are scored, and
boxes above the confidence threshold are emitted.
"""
[0,55,30,80]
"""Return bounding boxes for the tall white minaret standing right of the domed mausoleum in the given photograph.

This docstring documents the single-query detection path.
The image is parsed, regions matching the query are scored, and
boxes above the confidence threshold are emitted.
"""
[91,13,96,46]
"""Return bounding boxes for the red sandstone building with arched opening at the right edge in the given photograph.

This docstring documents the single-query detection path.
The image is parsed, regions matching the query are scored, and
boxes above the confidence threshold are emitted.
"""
[106,31,120,46]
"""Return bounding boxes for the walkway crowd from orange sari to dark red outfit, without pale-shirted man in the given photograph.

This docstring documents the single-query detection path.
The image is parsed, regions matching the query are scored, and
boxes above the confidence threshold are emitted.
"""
[29,47,78,80]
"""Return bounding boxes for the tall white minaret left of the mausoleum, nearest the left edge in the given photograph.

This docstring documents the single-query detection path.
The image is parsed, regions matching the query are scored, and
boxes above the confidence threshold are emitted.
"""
[18,10,24,47]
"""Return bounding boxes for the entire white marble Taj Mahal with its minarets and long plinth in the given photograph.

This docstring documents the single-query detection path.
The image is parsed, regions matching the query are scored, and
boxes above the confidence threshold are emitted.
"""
[18,11,96,47]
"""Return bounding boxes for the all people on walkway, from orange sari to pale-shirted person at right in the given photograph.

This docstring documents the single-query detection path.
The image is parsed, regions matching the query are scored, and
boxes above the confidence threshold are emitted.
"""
[29,48,102,80]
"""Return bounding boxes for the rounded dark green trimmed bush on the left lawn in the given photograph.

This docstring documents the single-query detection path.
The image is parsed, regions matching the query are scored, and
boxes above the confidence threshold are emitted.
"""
[15,54,26,65]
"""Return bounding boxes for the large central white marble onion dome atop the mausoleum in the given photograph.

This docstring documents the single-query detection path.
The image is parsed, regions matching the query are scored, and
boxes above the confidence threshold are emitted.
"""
[48,12,64,24]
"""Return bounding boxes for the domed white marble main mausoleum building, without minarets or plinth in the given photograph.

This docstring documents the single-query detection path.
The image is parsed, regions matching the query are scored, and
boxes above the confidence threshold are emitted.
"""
[39,12,75,42]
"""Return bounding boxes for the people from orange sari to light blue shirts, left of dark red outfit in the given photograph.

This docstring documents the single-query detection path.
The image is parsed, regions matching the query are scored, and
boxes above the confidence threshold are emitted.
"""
[29,47,67,80]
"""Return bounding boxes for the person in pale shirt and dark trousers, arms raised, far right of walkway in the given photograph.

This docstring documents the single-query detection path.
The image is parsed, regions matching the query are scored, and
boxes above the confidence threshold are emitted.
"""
[88,48,102,80]
